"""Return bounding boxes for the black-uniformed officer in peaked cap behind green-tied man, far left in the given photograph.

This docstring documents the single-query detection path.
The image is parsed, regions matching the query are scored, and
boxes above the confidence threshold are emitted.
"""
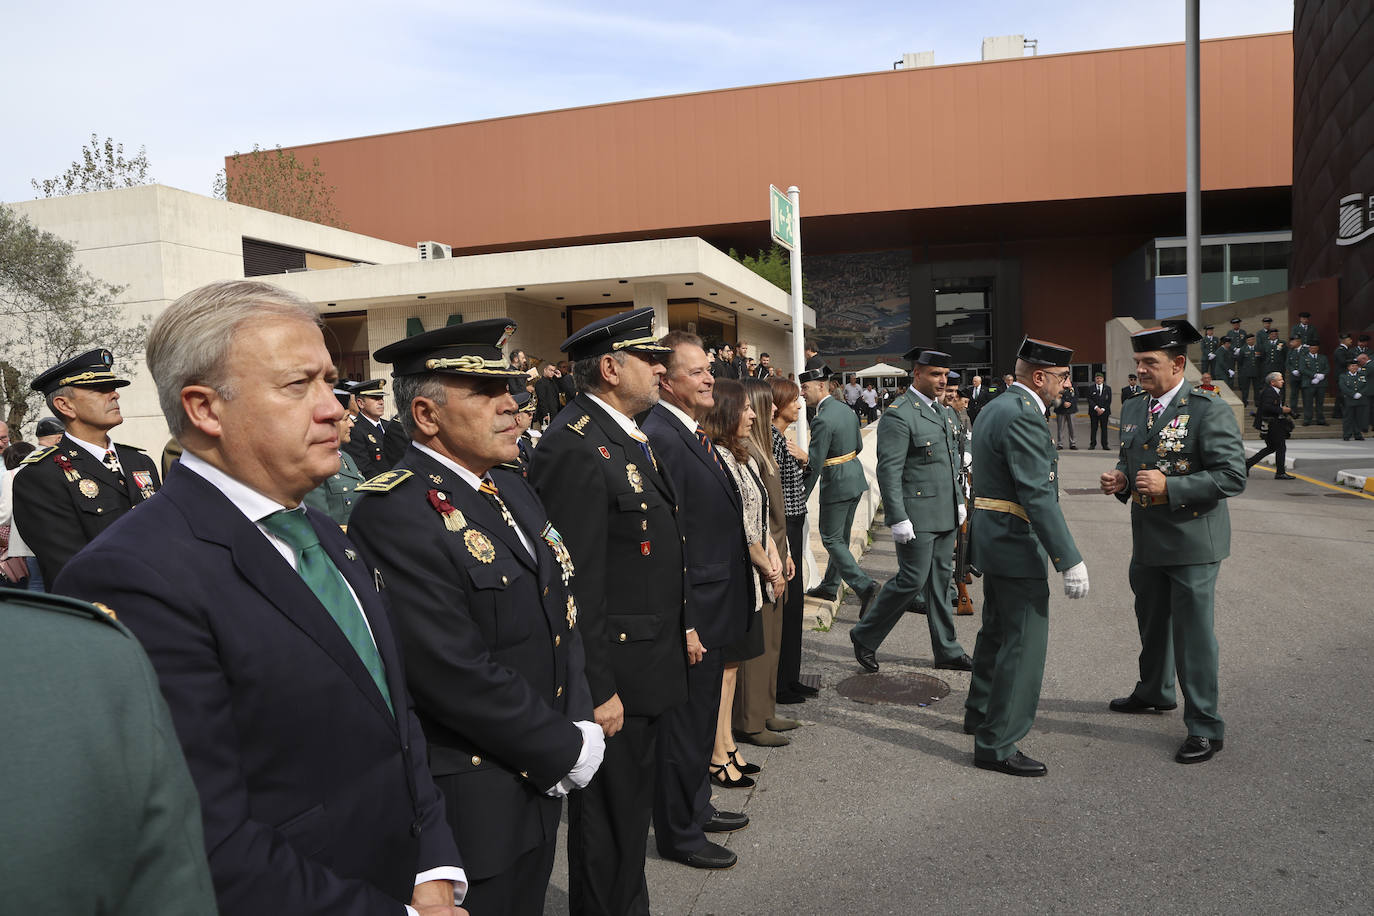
[14,350,162,584]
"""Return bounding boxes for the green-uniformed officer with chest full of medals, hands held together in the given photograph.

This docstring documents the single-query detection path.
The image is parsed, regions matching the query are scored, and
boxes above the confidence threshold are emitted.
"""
[1101,321,1245,764]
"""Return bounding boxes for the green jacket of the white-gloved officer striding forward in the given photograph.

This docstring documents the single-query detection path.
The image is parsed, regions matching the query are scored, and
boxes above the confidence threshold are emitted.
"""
[878,389,963,531]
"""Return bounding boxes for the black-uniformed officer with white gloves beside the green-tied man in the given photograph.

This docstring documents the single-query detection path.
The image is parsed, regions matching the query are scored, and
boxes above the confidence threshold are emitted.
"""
[349,319,606,916]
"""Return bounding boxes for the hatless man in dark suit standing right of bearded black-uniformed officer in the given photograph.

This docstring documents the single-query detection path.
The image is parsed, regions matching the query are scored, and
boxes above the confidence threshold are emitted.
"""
[644,331,752,868]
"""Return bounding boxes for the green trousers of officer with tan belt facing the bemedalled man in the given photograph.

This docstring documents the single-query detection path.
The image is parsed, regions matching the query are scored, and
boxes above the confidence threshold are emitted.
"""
[963,571,1050,761]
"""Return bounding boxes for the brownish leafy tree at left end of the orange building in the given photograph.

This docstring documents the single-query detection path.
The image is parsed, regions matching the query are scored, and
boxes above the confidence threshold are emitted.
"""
[213,143,348,229]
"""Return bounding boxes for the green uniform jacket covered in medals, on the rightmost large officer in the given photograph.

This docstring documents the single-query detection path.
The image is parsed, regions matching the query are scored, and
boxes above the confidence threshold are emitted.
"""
[1117,385,1245,566]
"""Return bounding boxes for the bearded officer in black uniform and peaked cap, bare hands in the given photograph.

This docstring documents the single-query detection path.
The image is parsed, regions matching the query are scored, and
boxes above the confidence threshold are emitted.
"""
[529,309,692,915]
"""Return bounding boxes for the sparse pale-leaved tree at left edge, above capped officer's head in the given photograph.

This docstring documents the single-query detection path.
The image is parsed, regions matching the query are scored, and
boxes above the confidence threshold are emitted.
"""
[0,205,150,438]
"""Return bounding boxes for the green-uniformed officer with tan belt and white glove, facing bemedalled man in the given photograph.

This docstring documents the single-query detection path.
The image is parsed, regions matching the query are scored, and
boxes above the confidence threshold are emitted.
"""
[963,338,1088,776]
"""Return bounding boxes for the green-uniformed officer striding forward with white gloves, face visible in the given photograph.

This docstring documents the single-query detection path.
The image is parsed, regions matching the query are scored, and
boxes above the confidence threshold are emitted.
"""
[849,347,973,672]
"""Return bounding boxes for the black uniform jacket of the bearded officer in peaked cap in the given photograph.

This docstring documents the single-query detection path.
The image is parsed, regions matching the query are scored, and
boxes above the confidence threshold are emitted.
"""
[529,394,687,715]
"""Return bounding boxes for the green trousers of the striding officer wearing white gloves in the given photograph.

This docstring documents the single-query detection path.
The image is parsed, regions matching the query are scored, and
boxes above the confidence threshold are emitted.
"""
[849,529,963,662]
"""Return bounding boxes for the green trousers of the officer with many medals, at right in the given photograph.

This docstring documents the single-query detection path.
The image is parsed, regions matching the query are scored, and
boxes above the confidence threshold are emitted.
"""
[1131,563,1226,739]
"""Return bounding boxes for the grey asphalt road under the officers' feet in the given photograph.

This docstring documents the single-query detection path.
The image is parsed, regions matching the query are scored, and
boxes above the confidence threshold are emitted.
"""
[547,436,1374,913]
